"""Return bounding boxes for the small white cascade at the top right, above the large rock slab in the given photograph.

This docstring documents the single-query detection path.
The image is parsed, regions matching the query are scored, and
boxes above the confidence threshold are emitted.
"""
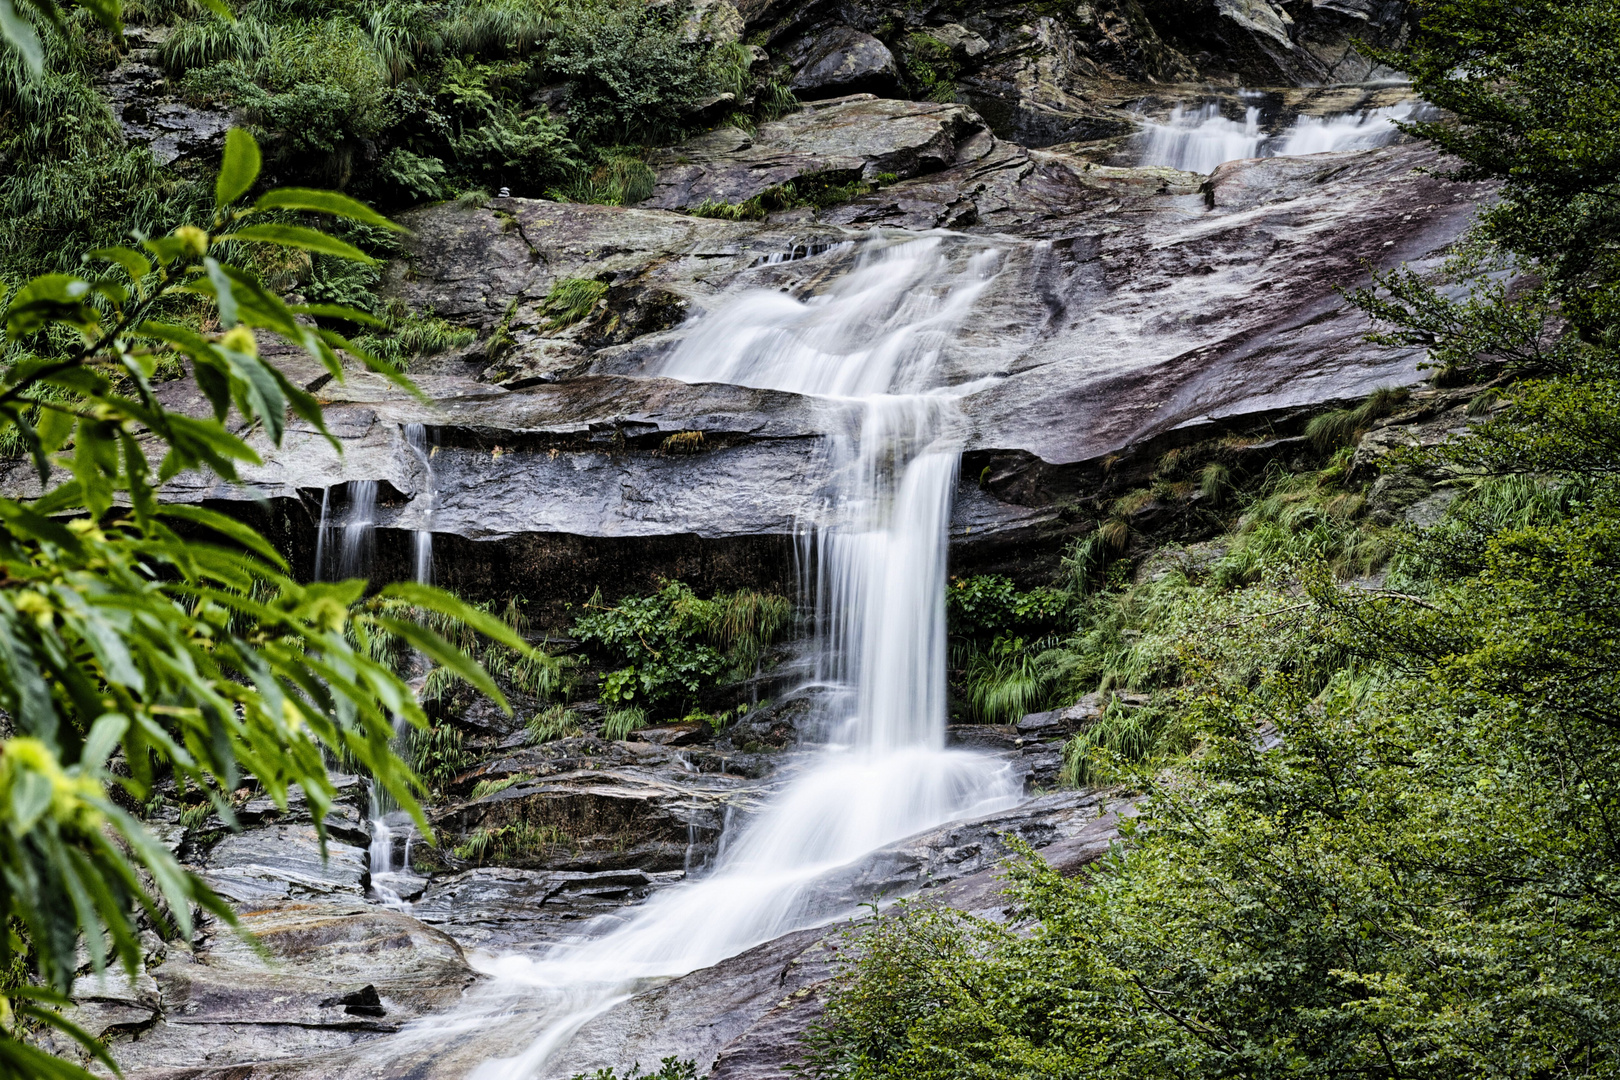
[1139,102,1418,173]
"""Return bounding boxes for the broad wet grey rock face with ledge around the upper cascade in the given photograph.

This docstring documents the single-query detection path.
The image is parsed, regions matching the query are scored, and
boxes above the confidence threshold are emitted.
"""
[31,118,1481,607]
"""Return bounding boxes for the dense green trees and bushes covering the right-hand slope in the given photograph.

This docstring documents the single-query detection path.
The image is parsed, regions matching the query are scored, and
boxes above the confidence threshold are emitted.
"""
[807,0,1620,1080]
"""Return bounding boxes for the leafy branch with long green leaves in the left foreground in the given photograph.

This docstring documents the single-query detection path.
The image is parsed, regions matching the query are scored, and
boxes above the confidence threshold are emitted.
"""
[0,130,530,1077]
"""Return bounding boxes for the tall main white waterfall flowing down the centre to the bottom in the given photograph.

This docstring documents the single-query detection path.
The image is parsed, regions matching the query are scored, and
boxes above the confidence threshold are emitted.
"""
[437,235,1019,1080]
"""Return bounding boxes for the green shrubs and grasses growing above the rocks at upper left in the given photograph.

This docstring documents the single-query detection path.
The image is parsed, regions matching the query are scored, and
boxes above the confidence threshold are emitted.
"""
[0,0,794,291]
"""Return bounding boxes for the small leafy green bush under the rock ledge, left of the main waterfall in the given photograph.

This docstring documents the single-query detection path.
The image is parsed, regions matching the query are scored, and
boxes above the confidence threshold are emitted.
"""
[573,581,792,718]
